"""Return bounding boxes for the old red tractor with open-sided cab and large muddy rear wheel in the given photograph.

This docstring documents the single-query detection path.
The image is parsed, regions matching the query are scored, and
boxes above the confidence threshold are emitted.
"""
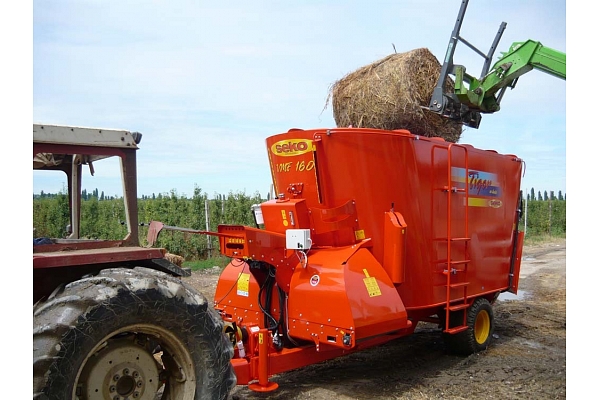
[33,124,235,400]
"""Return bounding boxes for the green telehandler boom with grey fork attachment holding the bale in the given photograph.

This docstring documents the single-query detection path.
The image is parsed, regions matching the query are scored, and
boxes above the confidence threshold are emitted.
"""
[429,0,567,128]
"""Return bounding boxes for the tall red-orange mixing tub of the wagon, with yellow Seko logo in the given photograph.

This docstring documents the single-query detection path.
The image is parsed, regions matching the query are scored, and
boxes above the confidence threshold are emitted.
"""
[262,128,522,310]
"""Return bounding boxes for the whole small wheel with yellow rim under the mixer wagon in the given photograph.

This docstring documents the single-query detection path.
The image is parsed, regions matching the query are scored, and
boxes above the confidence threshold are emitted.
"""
[443,298,494,355]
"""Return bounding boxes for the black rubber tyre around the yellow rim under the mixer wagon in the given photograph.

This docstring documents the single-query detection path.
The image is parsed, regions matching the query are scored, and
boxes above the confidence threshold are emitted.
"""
[442,297,495,355]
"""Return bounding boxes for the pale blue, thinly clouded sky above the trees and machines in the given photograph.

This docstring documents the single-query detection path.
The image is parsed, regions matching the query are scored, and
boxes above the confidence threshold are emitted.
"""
[32,0,566,197]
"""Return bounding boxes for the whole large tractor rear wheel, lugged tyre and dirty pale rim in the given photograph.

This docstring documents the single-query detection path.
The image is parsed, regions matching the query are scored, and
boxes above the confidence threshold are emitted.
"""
[33,268,236,400]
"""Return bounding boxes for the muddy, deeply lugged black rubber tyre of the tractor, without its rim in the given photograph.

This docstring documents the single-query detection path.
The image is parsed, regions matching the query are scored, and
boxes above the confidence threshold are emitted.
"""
[33,267,236,400]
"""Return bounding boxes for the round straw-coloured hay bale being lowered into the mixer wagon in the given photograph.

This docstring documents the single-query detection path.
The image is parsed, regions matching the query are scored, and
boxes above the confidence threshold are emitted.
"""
[325,48,463,142]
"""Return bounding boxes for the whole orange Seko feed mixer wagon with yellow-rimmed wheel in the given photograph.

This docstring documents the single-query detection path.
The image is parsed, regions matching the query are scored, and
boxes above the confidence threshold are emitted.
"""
[177,128,523,391]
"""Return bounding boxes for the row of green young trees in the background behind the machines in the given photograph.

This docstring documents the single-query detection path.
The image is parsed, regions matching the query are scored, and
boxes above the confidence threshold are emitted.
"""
[33,188,567,260]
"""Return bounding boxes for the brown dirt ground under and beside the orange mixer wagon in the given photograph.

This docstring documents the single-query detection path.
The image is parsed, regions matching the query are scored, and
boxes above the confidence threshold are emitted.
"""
[186,240,567,400]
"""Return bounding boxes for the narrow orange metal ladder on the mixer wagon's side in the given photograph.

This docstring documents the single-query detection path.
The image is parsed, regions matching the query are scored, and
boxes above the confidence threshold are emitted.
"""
[432,143,471,334]
